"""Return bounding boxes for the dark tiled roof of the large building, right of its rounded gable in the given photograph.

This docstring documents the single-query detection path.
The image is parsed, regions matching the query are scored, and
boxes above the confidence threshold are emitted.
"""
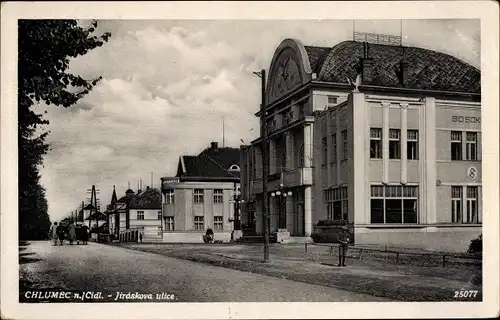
[316,41,481,93]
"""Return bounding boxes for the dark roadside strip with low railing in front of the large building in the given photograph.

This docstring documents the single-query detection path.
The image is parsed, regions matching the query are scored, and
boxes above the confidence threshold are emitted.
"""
[119,243,482,301]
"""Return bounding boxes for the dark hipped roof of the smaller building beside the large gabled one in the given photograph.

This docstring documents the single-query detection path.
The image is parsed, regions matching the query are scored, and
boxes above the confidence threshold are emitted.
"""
[177,148,240,179]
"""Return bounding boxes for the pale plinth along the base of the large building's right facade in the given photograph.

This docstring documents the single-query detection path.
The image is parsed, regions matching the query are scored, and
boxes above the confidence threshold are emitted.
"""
[355,226,482,253]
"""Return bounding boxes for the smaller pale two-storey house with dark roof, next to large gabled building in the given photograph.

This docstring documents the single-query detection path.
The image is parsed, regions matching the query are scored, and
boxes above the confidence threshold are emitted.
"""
[161,142,240,242]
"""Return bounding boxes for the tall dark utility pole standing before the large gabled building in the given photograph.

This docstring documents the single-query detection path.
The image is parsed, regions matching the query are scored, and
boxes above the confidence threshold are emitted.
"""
[254,69,269,262]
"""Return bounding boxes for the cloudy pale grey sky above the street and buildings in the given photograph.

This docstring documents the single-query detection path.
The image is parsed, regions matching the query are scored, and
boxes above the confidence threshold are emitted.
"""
[37,20,480,221]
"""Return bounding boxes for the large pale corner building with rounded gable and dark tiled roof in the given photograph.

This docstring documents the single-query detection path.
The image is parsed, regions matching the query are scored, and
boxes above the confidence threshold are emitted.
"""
[241,39,483,252]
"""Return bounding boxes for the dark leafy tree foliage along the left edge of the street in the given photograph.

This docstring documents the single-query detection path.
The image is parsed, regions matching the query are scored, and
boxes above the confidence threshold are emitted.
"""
[18,20,111,240]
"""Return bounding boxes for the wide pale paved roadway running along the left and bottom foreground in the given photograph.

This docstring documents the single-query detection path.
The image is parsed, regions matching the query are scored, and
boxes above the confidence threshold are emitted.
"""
[20,241,383,302]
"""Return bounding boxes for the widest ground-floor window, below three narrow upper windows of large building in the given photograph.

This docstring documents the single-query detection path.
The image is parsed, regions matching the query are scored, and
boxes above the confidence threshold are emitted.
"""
[370,186,418,224]
